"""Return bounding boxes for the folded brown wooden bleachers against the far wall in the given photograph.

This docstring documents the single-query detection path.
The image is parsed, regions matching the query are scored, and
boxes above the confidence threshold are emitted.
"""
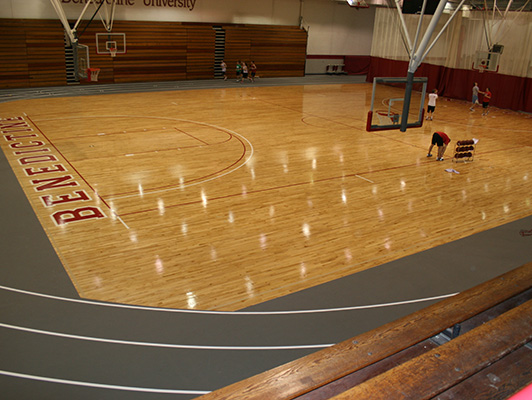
[0,18,307,88]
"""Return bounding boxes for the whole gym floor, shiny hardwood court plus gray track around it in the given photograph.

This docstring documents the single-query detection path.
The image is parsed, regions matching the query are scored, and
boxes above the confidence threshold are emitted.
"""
[0,77,532,399]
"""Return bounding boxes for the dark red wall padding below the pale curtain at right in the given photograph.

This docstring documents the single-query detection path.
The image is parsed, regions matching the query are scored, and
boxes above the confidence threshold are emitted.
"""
[367,57,532,112]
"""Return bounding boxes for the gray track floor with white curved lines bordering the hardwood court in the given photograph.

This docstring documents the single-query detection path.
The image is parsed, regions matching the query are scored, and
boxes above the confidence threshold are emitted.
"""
[0,76,532,400]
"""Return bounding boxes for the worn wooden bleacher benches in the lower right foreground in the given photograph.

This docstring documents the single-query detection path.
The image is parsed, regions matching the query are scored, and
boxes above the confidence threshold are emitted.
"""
[199,263,532,400]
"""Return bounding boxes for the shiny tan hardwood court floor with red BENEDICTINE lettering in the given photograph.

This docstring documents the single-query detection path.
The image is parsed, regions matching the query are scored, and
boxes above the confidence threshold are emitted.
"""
[0,84,532,310]
